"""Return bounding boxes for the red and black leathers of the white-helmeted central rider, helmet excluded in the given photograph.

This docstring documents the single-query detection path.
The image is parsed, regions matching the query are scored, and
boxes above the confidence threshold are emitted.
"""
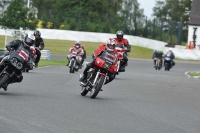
[79,44,118,84]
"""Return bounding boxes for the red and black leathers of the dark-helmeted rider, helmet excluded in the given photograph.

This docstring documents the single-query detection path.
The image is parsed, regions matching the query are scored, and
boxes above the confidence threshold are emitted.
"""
[114,38,131,72]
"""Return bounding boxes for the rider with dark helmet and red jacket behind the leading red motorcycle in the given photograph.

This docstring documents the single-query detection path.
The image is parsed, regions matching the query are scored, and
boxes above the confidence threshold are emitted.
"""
[114,30,131,72]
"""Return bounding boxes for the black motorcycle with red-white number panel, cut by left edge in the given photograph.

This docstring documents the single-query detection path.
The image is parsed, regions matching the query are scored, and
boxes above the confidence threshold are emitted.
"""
[0,48,29,88]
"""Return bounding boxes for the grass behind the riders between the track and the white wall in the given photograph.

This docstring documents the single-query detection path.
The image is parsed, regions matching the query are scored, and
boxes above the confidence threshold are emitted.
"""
[0,36,158,67]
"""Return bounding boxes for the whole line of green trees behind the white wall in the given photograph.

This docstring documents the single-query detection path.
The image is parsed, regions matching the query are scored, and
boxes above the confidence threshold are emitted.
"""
[0,0,191,43]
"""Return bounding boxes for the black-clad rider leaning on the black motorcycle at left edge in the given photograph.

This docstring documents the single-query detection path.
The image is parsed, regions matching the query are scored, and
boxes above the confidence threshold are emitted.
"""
[0,34,35,91]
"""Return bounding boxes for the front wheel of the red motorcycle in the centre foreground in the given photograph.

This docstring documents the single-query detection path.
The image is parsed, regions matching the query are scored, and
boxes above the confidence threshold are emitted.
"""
[90,75,105,99]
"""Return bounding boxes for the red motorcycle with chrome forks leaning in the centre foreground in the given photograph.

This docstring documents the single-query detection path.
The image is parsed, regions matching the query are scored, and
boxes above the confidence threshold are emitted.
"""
[81,51,117,99]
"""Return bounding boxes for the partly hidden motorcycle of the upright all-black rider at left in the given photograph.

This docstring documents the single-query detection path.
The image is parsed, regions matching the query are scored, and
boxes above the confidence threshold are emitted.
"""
[23,46,37,72]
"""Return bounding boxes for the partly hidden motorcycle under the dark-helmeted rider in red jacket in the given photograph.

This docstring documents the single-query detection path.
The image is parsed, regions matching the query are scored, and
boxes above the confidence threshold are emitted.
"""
[115,47,125,75]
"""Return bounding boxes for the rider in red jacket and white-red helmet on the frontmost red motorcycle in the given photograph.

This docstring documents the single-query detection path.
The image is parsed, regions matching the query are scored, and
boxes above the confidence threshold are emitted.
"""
[79,38,118,84]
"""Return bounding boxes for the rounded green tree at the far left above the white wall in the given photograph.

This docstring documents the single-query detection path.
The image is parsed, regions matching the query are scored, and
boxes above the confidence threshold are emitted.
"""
[0,0,36,30]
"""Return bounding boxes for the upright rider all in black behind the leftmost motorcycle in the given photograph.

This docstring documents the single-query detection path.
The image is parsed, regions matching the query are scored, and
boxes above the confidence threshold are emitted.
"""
[34,30,45,67]
